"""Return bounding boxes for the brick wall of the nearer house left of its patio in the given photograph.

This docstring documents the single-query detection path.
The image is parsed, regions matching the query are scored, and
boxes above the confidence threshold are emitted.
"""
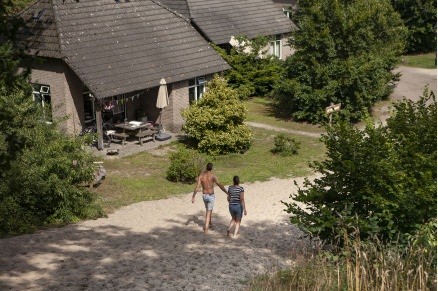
[31,59,84,134]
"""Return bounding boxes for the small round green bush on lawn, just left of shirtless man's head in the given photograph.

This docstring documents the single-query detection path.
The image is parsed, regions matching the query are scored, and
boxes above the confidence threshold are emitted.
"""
[166,148,206,184]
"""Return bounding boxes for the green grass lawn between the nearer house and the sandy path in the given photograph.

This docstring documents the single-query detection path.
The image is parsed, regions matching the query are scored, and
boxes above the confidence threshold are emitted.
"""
[95,128,325,213]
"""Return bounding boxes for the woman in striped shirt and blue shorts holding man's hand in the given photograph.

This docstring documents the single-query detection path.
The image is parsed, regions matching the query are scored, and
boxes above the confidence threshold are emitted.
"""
[227,176,246,237]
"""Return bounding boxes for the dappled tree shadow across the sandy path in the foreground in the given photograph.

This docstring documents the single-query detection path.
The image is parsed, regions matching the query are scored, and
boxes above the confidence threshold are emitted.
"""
[0,212,306,290]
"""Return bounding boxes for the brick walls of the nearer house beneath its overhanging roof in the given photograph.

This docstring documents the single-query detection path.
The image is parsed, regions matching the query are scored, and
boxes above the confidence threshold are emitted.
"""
[27,59,214,134]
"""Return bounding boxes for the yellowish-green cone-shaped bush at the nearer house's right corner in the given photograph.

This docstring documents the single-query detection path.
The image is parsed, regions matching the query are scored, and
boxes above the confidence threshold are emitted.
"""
[182,75,252,155]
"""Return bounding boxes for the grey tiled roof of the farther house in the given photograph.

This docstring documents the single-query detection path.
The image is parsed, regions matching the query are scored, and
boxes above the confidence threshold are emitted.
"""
[159,0,296,44]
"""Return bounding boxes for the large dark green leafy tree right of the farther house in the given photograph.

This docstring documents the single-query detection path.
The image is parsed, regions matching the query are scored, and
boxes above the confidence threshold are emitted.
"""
[272,0,405,123]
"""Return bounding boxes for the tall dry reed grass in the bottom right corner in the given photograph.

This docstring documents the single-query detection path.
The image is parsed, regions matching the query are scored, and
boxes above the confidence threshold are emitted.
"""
[245,220,437,291]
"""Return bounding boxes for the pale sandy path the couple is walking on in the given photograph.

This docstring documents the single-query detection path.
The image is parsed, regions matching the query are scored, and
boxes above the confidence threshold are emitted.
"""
[0,178,316,290]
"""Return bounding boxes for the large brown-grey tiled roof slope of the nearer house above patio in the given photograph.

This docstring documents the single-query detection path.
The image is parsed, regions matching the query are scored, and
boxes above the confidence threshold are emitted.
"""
[15,0,230,98]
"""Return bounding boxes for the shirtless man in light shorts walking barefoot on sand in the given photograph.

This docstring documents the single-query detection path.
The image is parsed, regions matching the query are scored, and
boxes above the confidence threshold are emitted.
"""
[192,163,228,233]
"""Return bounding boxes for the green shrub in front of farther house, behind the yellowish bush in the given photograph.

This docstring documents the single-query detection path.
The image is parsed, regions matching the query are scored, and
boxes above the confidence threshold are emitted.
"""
[212,36,283,99]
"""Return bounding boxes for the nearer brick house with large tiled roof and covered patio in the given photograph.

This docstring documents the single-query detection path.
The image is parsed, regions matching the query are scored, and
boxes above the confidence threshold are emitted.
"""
[14,0,230,148]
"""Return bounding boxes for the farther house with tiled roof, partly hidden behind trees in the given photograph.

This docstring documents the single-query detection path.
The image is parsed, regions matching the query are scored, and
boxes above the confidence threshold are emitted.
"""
[157,0,297,60]
